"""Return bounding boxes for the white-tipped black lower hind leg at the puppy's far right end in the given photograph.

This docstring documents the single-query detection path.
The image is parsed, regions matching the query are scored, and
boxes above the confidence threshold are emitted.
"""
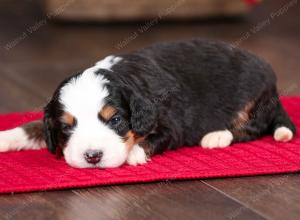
[272,102,296,142]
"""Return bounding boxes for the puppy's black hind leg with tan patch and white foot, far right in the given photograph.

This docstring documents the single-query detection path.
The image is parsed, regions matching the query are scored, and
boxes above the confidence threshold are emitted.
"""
[230,91,296,142]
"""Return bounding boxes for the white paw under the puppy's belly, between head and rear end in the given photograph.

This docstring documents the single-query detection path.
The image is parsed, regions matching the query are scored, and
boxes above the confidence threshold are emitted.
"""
[201,130,233,149]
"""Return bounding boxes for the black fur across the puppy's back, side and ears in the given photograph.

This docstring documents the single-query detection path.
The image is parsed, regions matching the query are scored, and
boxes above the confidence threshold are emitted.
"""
[45,39,296,156]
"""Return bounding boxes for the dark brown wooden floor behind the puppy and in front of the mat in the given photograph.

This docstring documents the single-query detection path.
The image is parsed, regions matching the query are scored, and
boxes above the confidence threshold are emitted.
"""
[0,0,300,220]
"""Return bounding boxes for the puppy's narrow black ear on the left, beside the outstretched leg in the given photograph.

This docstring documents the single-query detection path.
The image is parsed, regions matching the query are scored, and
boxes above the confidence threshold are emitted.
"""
[43,109,57,154]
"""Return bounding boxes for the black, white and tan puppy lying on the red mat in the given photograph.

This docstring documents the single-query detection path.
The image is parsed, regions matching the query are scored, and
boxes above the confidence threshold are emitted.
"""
[0,39,296,168]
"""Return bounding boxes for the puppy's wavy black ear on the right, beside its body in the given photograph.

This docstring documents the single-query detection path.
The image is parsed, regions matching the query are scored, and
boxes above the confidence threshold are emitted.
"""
[130,95,157,136]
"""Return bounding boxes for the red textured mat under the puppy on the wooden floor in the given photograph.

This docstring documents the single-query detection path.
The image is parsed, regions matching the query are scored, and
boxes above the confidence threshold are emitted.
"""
[0,97,300,193]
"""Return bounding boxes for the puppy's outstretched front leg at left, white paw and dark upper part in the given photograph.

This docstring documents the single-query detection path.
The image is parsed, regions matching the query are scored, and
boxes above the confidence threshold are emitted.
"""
[0,120,46,152]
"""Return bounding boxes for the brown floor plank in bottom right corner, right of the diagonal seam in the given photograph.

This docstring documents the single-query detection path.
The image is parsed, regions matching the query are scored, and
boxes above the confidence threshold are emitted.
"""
[205,174,300,220]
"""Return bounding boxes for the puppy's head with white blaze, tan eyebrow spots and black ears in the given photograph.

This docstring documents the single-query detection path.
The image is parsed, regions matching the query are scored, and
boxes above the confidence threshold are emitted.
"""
[44,69,156,168]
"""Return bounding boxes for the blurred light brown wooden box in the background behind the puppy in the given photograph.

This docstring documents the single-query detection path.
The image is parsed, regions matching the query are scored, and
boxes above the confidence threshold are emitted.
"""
[46,0,250,21]
